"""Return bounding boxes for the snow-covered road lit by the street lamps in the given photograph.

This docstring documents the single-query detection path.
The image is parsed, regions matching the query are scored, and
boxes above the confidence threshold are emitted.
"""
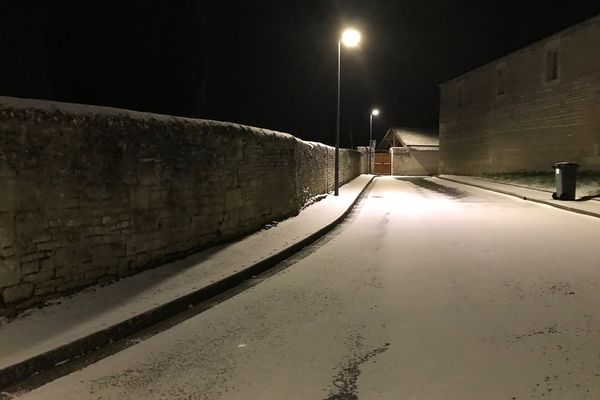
[15,177,600,400]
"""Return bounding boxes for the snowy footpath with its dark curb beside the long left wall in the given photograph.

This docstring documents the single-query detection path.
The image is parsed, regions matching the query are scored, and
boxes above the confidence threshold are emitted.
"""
[0,175,374,393]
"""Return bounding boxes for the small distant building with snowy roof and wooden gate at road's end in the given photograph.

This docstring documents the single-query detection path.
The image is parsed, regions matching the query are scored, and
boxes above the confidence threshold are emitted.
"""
[375,128,439,175]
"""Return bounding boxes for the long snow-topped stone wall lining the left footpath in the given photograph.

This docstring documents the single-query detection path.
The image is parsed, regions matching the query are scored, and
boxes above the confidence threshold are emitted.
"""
[0,97,361,315]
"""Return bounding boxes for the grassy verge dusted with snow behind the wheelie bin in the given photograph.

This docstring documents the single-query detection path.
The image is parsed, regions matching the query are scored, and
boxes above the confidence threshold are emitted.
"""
[480,171,600,196]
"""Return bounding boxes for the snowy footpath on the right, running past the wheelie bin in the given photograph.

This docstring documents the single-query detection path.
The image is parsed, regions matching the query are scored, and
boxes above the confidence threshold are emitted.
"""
[439,175,600,218]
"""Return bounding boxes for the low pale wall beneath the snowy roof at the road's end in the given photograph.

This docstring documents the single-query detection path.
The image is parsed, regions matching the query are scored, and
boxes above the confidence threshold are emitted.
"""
[390,147,439,175]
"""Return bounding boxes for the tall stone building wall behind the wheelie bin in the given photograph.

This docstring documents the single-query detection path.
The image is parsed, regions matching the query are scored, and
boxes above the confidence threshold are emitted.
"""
[440,17,600,174]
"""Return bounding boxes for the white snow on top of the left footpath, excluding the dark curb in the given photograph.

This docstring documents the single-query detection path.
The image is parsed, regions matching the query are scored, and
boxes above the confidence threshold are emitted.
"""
[0,175,371,368]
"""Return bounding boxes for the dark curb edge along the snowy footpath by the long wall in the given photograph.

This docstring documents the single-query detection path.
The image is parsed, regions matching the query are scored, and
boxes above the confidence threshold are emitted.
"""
[0,176,375,391]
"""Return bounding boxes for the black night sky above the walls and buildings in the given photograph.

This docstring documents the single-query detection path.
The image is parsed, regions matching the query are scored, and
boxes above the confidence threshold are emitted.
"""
[0,0,600,147]
